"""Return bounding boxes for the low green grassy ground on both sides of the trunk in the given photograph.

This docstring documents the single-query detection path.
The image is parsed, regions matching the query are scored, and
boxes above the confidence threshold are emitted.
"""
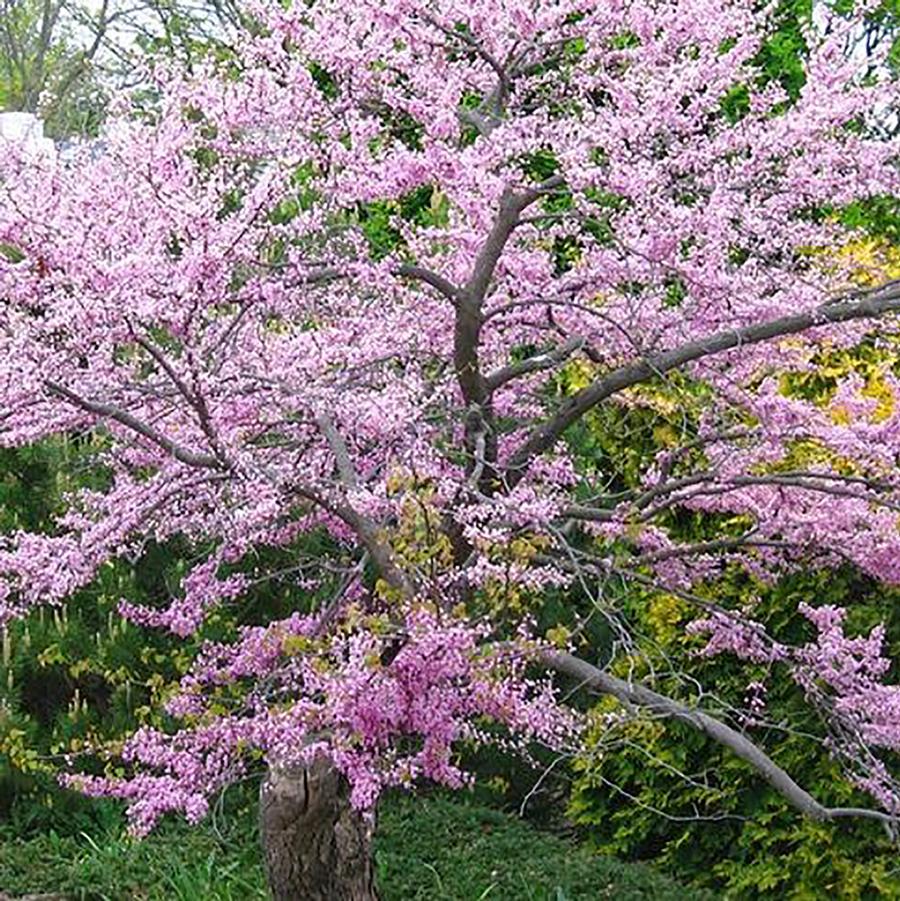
[0,797,709,901]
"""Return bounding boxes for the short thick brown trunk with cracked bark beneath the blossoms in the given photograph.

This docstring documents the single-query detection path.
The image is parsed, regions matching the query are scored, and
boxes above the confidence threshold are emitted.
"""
[259,758,378,901]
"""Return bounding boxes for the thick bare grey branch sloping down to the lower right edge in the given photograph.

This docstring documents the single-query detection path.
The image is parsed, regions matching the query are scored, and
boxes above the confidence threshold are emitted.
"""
[541,651,897,830]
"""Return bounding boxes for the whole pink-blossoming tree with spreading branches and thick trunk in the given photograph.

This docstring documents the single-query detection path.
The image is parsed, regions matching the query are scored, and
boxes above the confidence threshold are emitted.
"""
[0,0,900,898]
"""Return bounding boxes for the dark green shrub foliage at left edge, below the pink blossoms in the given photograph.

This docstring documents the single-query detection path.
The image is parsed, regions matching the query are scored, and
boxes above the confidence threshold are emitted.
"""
[0,532,199,830]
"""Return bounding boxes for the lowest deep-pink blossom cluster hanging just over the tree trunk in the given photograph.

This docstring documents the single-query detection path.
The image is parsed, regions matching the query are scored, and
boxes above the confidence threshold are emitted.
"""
[64,607,580,834]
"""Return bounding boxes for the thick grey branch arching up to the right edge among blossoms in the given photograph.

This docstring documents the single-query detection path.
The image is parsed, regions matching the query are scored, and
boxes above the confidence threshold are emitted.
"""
[506,282,900,487]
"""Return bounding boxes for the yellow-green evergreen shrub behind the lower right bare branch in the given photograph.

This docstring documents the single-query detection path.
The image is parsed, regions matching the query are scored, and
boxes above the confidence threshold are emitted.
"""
[570,570,900,899]
